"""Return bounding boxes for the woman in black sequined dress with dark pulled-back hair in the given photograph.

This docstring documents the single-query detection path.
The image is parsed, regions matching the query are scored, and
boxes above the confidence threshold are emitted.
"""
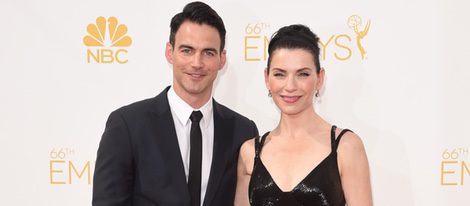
[235,25,372,206]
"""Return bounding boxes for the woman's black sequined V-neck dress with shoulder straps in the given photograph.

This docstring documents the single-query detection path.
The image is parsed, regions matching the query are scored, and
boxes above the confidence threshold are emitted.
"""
[249,126,350,206]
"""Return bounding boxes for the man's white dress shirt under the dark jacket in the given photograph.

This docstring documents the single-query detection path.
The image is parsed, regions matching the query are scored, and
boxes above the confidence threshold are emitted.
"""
[167,87,214,205]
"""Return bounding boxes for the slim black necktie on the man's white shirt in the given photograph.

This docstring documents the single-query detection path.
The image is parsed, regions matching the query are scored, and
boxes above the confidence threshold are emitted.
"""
[188,111,202,206]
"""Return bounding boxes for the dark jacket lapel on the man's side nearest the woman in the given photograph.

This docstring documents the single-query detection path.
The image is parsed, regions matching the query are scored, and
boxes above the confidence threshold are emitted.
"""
[204,100,233,205]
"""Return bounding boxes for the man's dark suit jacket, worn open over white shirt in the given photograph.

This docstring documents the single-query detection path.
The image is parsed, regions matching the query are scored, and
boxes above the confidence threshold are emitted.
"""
[93,87,258,206]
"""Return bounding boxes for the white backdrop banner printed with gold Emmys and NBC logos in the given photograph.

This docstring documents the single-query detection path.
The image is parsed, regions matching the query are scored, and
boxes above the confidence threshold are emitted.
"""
[0,0,470,206]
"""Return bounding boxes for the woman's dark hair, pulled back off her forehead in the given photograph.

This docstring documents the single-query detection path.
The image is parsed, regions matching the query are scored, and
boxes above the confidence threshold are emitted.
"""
[267,24,321,74]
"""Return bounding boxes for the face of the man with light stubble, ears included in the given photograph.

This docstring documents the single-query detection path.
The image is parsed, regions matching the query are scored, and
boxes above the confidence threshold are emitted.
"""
[165,21,226,101]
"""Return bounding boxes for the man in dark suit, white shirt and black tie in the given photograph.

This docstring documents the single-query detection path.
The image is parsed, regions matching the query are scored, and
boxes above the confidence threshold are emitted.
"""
[93,2,258,206]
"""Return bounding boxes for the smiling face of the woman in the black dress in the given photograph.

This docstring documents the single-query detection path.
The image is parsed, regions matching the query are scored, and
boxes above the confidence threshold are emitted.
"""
[264,48,325,115]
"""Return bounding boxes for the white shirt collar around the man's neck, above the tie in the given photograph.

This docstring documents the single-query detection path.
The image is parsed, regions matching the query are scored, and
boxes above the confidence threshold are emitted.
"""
[167,87,213,128]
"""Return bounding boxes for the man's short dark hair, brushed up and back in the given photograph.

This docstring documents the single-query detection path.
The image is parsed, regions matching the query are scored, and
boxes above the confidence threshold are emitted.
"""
[170,1,226,51]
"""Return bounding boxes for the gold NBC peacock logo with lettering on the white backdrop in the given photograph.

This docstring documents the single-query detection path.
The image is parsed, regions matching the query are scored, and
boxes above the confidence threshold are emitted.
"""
[83,16,132,64]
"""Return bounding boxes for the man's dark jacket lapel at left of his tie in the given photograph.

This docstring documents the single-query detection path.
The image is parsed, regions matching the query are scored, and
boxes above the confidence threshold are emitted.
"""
[151,87,189,202]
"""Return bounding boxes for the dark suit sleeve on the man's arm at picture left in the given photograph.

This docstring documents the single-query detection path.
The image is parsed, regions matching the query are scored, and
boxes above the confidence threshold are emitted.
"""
[92,110,135,206]
